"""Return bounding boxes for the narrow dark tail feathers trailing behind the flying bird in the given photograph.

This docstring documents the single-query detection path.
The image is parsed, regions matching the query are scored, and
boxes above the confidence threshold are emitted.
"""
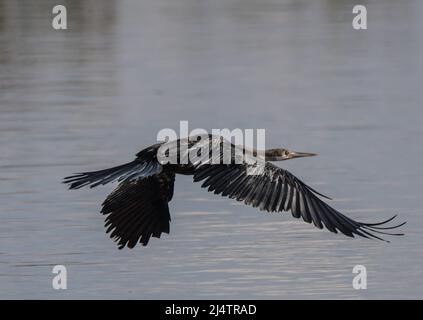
[63,160,140,189]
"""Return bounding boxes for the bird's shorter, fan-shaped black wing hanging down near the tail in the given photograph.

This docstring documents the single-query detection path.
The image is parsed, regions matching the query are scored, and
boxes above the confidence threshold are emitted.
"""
[101,172,175,249]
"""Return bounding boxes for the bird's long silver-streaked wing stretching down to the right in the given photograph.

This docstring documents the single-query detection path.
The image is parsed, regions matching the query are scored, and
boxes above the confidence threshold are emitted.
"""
[194,161,405,241]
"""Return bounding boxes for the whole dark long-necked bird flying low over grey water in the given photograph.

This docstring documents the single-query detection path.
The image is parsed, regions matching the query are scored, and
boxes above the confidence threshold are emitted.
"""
[63,135,405,249]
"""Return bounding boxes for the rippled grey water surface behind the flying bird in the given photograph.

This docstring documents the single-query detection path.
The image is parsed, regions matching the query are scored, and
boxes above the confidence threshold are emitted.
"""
[0,0,423,299]
